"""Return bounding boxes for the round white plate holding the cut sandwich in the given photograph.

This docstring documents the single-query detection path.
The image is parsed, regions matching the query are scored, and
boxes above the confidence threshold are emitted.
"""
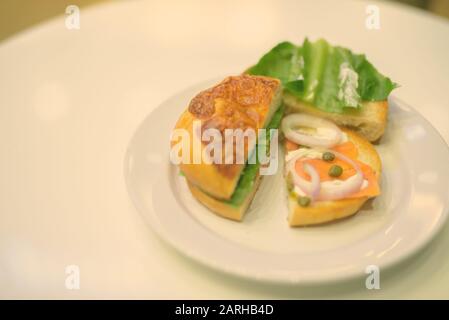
[125,81,449,283]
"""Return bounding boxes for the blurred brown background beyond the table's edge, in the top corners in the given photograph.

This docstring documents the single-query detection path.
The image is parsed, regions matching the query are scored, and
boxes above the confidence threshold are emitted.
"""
[0,0,449,41]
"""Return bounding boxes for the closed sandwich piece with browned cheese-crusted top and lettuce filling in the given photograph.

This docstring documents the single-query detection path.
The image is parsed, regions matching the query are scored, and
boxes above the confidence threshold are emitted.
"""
[171,75,282,220]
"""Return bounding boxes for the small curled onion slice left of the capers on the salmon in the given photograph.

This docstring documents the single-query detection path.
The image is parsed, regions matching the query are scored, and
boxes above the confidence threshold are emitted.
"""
[287,154,320,200]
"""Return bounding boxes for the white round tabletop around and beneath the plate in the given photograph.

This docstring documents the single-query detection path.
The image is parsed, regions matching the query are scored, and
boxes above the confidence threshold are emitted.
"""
[0,0,449,299]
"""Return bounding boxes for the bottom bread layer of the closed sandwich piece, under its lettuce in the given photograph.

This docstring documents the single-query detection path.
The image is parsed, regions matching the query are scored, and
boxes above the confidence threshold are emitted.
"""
[187,175,262,221]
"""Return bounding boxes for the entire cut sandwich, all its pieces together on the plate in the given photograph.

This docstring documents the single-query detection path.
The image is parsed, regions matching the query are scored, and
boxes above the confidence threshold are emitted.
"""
[172,39,396,226]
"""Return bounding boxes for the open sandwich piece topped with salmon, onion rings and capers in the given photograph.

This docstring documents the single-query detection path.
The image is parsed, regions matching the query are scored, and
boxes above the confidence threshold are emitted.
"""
[282,114,381,226]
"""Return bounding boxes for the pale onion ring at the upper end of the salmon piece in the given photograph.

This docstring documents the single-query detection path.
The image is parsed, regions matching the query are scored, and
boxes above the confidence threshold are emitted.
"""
[281,114,342,148]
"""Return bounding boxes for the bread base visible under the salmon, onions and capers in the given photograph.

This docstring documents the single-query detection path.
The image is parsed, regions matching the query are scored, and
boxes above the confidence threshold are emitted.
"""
[288,129,382,227]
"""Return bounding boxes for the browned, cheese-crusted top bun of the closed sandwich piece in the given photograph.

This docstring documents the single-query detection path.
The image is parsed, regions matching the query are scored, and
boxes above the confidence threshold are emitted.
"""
[171,75,282,199]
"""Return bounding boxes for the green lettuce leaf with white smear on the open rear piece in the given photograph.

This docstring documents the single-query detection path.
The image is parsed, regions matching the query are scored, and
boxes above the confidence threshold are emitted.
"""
[247,39,397,113]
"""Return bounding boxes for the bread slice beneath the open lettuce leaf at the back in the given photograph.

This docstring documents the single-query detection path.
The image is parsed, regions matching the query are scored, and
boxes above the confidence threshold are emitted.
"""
[283,90,388,142]
